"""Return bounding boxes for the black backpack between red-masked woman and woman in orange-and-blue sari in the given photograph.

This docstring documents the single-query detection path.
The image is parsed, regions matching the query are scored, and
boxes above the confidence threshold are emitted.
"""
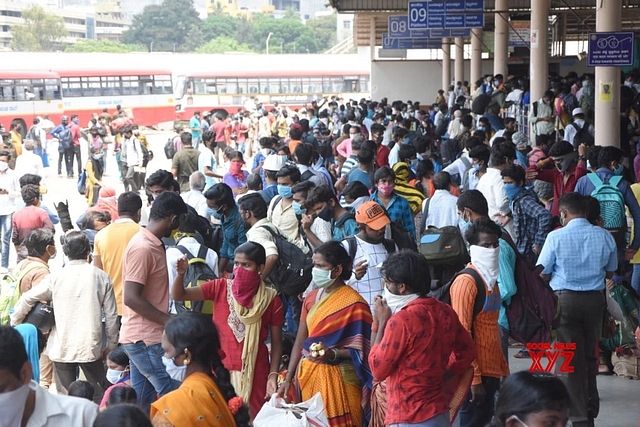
[261,225,313,296]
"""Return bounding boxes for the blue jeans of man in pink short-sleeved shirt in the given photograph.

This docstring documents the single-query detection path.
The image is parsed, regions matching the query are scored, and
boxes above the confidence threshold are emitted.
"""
[122,341,180,413]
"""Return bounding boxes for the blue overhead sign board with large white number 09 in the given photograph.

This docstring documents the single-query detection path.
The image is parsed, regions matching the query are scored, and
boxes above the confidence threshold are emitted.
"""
[408,0,484,30]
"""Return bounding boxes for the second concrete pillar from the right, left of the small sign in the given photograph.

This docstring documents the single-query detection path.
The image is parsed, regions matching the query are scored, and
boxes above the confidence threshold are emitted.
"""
[529,0,551,110]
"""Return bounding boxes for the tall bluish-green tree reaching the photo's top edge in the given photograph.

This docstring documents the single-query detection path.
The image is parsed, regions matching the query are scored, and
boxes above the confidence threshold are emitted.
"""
[122,0,203,52]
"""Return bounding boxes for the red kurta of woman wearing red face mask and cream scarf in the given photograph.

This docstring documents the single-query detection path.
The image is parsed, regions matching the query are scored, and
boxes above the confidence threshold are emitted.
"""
[202,279,284,415]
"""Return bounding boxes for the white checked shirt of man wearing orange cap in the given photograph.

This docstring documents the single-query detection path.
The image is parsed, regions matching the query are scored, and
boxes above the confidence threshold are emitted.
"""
[342,236,396,310]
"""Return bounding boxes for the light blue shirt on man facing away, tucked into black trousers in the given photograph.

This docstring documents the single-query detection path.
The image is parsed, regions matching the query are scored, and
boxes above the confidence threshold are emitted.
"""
[538,218,618,291]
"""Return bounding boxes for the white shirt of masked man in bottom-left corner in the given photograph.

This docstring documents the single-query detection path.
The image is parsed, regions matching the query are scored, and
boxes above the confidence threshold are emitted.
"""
[27,380,98,427]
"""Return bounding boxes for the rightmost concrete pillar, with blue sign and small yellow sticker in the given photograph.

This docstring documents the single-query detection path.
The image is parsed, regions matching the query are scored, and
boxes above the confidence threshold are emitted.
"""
[594,0,626,149]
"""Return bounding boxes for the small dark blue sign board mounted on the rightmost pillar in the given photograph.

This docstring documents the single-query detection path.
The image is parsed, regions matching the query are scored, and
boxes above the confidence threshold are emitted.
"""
[587,32,634,67]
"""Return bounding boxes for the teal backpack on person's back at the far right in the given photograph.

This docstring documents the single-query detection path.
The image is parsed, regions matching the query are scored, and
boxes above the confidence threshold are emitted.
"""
[587,173,627,244]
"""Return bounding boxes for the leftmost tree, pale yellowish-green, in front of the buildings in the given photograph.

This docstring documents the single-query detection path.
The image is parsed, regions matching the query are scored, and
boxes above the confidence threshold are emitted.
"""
[9,5,68,52]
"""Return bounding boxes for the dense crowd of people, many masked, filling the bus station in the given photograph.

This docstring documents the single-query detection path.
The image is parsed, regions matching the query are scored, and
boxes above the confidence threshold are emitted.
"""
[0,73,640,427]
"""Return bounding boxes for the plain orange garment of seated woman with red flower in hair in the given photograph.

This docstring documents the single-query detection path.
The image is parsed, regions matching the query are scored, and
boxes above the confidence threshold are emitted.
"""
[151,372,236,427]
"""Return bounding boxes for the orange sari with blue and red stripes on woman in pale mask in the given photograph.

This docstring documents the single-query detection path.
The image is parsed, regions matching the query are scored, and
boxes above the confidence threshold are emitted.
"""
[297,285,373,427]
